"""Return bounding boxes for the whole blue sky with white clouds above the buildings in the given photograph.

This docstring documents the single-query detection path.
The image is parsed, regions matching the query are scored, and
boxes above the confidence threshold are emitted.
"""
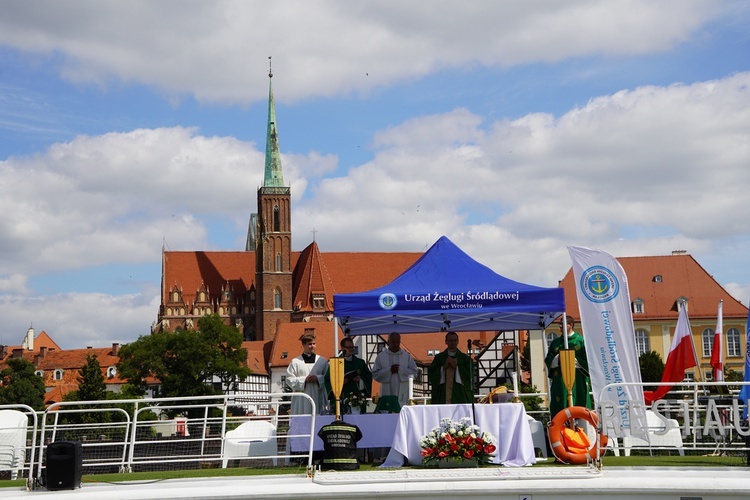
[0,0,750,348]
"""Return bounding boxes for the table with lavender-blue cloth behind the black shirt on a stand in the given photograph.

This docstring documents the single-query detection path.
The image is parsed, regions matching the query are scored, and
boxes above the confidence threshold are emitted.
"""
[289,413,406,452]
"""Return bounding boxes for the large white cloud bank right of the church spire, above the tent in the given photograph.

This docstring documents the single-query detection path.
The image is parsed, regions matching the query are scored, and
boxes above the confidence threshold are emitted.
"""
[295,73,750,301]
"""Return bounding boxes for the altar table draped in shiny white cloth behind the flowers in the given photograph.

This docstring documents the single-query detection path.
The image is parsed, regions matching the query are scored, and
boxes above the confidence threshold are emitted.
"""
[381,403,536,467]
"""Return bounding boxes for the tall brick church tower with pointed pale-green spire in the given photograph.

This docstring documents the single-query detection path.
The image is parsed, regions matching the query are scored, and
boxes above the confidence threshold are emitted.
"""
[255,65,292,340]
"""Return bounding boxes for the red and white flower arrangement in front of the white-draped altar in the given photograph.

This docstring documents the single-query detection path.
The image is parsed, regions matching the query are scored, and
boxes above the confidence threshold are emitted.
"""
[419,418,497,465]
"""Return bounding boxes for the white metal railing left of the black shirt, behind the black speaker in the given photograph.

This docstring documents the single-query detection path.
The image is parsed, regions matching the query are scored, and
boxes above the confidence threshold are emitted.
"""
[0,393,315,489]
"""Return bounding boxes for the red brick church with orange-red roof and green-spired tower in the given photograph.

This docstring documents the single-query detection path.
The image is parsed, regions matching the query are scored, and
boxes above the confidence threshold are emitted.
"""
[152,68,452,396]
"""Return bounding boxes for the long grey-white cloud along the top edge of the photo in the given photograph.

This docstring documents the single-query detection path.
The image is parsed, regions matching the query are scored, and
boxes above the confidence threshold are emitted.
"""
[0,0,726,103]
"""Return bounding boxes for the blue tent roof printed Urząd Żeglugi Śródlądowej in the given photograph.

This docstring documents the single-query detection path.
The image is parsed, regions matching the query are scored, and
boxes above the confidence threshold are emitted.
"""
[333,236,565,335]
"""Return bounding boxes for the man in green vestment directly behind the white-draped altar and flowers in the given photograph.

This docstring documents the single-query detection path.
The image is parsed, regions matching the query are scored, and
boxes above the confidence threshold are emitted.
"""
[427,332,474,404]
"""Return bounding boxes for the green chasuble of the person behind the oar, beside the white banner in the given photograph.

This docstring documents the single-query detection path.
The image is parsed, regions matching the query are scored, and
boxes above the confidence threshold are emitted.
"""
[544,332,593,418]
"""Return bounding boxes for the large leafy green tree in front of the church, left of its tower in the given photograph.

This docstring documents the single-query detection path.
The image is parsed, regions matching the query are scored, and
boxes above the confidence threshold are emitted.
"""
[117,314,250,404]
